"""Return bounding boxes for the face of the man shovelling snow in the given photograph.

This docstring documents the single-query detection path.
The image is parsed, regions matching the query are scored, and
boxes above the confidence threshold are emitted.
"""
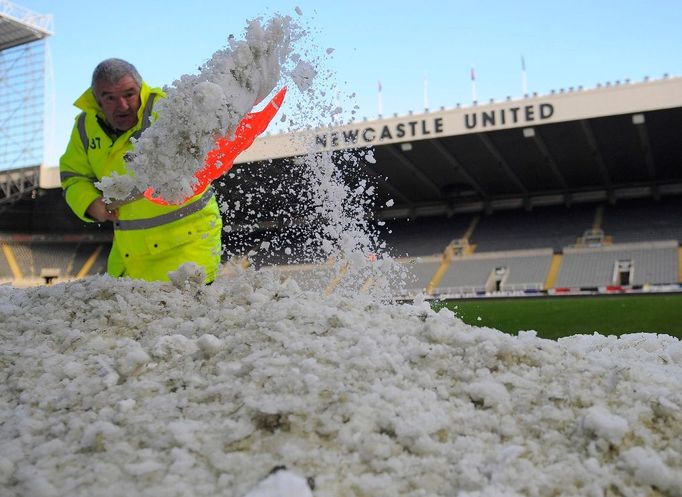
[94,76,140,131]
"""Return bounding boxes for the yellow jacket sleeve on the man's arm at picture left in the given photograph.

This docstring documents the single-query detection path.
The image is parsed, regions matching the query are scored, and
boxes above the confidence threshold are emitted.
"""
[59,116,102,222]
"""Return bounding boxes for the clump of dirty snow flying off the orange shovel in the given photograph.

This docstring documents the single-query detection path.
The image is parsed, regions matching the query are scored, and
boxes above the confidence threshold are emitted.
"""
[97,15,304,203]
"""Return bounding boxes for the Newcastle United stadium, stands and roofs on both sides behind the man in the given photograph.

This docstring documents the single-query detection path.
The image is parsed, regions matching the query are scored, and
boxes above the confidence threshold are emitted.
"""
[0,2,682,334]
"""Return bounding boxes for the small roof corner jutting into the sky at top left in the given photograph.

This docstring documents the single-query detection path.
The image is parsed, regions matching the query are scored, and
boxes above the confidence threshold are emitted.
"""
[0,0,52,51]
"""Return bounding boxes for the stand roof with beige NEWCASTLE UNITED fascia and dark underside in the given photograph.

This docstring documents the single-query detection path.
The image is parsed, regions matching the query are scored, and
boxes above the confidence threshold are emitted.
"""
[224,77,682,221]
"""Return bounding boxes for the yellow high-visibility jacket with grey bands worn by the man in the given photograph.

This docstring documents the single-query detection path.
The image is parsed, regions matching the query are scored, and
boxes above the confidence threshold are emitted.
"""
[59,82,222,282]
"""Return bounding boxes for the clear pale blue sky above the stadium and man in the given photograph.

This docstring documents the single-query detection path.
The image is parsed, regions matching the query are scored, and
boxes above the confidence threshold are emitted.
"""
[15,0,682,165]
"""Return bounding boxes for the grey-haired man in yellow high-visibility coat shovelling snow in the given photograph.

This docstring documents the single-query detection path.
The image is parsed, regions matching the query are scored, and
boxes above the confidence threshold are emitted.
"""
[59,59,222,283]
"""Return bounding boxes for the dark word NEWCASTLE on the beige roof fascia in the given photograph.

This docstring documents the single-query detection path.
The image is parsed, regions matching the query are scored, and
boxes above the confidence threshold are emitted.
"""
[315,117,443,148]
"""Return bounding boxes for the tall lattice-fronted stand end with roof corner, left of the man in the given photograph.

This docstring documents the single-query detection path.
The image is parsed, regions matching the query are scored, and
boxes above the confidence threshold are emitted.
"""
[0,0,52,204]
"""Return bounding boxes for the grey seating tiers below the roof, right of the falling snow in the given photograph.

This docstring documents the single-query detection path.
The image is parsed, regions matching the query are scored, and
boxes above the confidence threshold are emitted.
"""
[366,197,682,296]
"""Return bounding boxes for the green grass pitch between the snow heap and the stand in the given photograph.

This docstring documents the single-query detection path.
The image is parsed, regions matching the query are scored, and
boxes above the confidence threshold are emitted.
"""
[434,294,682,339]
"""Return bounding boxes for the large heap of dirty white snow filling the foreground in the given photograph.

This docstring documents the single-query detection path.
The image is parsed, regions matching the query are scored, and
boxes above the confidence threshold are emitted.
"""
[0,271,682,497]
